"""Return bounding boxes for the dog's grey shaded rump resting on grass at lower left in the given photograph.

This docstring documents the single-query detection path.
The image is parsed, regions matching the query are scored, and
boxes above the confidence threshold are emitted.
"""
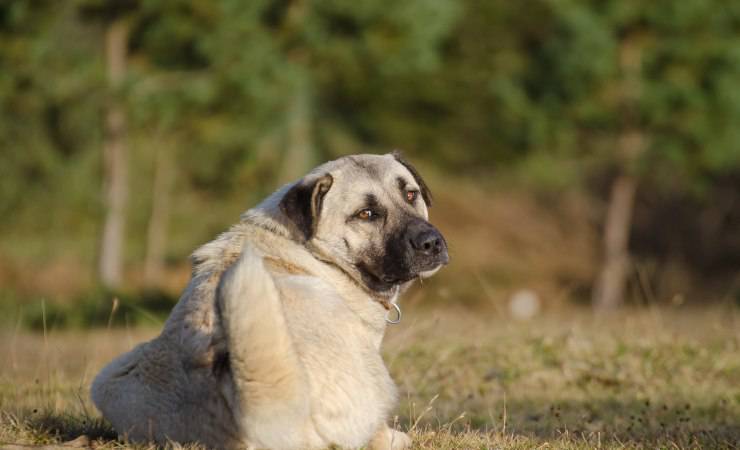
[91,326,239,448]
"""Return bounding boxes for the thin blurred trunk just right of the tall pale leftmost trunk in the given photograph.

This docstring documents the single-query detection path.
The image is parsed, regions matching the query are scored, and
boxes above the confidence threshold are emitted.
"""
[144,145,175,287]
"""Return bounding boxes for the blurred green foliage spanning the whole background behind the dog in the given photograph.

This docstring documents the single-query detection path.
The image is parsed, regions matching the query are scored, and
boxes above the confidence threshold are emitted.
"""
[0,0,740,298]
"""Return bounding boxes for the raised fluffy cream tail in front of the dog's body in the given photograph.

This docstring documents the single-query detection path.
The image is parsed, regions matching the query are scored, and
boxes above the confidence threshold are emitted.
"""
[219,248,311,449]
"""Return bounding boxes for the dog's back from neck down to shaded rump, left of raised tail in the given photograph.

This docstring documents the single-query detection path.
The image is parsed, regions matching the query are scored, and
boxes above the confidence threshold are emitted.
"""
[91,225,250,448]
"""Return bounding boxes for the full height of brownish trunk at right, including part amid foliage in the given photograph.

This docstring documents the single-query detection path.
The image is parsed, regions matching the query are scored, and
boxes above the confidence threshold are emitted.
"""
[593,35,645,312]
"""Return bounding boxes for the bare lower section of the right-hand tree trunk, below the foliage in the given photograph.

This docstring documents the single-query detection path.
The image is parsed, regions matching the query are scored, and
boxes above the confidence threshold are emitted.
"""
[593,174,637,311]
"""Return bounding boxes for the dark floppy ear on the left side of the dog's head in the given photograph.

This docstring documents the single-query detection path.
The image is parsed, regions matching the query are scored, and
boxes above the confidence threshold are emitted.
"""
[280,173,334,241]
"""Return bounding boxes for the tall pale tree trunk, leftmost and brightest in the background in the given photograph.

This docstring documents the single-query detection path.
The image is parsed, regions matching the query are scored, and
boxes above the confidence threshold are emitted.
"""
[99,19,129,289]
